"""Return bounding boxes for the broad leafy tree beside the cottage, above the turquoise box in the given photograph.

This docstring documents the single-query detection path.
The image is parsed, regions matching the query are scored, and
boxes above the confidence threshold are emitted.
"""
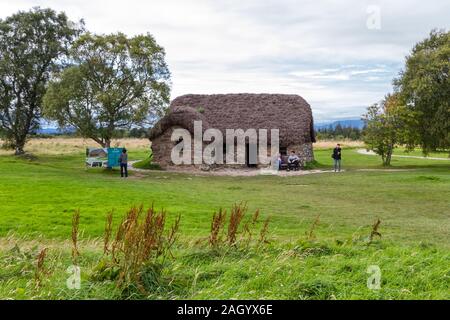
[44,33,170,147]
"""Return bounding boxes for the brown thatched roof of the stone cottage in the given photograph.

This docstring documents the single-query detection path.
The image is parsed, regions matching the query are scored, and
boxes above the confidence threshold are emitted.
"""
[149,93,315,146]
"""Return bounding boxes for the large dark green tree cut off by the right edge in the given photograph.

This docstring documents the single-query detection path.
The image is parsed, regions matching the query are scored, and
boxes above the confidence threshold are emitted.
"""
[394,30,450,154]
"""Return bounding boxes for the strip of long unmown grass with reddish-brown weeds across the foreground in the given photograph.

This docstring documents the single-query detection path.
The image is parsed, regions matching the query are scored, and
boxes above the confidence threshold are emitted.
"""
[0,203,422,299]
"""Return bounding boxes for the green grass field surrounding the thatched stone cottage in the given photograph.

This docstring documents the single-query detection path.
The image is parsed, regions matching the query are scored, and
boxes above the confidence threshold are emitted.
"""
[0,139,450,299]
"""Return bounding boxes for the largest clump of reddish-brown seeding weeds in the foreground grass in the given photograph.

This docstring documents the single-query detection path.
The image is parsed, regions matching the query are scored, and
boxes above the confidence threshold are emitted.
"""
[93,206,180,293]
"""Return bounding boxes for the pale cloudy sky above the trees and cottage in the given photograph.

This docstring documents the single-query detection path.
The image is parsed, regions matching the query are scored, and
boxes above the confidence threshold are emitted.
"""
[0,0,450,122]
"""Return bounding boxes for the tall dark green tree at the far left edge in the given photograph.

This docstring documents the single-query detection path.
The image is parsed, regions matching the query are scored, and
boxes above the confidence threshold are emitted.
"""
[0,8,83,155]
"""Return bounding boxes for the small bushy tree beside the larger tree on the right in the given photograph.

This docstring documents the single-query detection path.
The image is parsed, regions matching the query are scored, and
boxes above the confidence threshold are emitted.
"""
[363,94,412,166]
